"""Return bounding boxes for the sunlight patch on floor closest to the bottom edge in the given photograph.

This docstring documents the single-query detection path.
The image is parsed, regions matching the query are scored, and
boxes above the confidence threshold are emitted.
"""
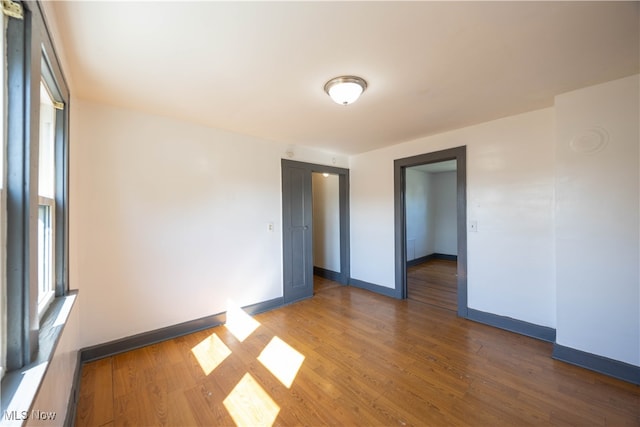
[222,373,280,427]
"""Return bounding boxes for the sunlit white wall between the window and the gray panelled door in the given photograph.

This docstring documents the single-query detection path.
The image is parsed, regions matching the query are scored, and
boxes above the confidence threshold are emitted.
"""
[70,101,347,346]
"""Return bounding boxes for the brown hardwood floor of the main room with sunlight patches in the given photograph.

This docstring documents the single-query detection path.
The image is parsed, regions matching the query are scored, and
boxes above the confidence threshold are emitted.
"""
[76,276,640,426]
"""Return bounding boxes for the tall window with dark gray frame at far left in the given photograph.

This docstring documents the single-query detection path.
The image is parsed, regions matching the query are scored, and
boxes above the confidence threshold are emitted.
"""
[0,2,69,376]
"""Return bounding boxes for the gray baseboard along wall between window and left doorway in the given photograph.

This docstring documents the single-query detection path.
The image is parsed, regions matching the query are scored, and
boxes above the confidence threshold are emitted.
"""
[80,297,284,363]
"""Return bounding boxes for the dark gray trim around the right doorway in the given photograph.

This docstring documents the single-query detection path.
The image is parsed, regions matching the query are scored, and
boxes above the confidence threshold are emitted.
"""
[393,146,468,318]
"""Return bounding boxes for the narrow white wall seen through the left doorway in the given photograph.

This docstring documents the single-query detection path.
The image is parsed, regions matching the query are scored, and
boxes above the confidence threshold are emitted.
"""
[311,173,340,273]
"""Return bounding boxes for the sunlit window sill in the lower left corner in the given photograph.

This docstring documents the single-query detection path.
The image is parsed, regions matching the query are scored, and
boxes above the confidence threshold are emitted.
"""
[0,291,78,426]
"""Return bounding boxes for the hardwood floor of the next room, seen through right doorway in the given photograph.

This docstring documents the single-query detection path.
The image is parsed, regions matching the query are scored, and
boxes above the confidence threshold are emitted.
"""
[407,259,458,311]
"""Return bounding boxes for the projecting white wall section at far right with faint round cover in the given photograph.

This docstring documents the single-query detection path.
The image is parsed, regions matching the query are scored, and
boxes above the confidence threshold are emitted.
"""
[555,76,640,366]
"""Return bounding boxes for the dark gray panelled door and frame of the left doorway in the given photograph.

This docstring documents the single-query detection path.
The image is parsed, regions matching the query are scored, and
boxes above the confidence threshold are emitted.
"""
[281,159,350,304]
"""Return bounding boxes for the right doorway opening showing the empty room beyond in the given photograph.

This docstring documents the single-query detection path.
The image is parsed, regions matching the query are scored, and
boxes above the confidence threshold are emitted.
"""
[405,160,458,311]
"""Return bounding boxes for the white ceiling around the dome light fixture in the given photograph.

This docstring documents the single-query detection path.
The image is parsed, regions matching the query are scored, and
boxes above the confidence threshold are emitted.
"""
[45,1,640,154]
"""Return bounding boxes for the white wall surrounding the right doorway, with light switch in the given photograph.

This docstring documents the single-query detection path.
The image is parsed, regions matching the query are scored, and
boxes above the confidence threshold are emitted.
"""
[350,108,556,327]
